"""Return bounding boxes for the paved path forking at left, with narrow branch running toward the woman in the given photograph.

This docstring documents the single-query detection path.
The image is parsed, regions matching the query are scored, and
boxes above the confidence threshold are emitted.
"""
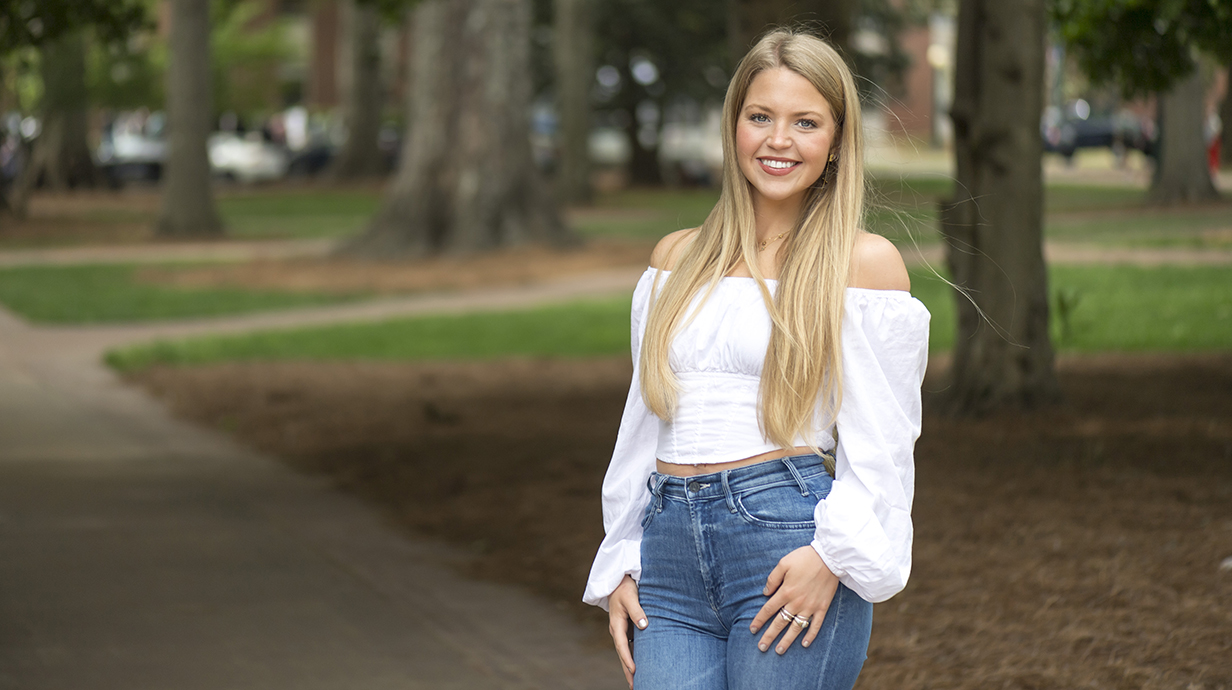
[0,271,638,690]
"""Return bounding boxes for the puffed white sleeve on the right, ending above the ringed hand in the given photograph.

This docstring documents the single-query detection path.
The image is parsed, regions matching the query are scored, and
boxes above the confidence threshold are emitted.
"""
[813,288,929,603]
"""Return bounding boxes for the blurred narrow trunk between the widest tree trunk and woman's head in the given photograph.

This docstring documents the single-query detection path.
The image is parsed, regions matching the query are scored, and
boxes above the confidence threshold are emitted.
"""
[554,0,595,203]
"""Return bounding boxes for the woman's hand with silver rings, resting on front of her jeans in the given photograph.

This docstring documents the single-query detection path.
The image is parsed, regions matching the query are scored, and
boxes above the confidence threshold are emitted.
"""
[749,546,839,654]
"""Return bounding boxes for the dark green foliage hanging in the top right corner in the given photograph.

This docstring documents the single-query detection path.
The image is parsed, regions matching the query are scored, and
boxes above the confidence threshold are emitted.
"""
[1051,0,1232,96]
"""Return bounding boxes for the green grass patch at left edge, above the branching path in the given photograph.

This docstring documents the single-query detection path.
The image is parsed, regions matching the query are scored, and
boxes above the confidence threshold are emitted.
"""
[0,265,359,323]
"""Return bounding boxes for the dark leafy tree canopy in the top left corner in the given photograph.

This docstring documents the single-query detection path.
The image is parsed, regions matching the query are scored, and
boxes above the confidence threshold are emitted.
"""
[0,0,148,54]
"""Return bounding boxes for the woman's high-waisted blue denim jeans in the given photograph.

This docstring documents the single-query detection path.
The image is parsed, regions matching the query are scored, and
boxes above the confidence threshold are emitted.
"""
[631,455,872,690]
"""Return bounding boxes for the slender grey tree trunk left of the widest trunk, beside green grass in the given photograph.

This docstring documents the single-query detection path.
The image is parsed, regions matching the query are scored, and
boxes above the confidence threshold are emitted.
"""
[155,0,223,237]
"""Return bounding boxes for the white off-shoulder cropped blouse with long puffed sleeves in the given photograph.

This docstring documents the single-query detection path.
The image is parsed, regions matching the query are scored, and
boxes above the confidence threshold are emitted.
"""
[583,269,929,609]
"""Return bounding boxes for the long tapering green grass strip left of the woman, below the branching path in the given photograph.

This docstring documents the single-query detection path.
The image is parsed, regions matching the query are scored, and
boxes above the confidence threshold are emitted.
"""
[107,298,628,371]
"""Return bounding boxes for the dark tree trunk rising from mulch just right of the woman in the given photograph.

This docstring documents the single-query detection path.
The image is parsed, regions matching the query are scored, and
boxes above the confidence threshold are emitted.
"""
[941,0,1060,414]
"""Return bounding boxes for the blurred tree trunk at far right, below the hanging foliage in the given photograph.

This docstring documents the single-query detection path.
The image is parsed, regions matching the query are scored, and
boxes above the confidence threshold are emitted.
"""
[1151,70,1220,203]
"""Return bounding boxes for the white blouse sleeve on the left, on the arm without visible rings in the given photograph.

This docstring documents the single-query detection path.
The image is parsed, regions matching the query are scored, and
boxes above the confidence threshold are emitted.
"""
[582,269,659,610]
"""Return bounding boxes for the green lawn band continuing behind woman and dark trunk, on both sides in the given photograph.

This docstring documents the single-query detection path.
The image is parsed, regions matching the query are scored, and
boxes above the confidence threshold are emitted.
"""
[107,266,1232,370]
